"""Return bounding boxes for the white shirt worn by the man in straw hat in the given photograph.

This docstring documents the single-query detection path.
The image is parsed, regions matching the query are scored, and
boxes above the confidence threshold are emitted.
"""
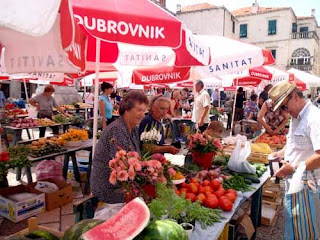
[285,102,320,187]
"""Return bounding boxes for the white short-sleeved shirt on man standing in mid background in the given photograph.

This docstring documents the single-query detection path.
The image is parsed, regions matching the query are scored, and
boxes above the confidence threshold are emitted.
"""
[192,89,210,123]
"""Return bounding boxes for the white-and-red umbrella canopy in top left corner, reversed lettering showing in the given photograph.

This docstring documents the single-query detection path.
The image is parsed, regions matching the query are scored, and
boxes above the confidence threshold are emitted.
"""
[0,0,86,73]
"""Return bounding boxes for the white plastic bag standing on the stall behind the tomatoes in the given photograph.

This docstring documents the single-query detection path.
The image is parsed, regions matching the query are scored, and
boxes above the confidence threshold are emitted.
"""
[228,140,256,173]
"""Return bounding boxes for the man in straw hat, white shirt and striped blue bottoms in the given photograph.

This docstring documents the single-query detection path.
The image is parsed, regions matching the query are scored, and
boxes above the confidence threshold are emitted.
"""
[269,81,320,239]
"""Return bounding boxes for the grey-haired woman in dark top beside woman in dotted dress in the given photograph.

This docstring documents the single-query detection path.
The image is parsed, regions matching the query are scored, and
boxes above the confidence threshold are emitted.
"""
[139,95,179,154]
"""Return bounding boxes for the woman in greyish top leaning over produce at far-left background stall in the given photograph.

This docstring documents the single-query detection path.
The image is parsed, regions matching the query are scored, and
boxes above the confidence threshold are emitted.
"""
[29,85,70,138]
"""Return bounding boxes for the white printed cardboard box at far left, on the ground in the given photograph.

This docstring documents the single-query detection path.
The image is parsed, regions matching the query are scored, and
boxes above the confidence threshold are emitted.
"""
[0,184,46,223]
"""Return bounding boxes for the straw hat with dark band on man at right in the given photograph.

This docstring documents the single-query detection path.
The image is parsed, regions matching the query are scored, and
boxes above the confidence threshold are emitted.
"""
[268,81,296,111]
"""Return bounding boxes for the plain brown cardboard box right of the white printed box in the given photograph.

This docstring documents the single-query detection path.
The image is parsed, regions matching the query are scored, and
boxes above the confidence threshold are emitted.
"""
[33,178,72,211]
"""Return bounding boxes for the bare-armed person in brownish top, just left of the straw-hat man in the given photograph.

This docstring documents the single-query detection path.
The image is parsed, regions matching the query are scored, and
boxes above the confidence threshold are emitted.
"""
[258,99,289,135]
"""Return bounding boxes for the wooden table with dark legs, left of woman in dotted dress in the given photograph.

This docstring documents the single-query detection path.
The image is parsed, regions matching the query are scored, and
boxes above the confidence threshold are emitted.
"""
[16,139,93,193]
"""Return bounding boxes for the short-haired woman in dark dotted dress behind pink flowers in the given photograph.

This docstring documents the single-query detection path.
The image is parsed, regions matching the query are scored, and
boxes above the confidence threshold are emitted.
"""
[91,90,148,204]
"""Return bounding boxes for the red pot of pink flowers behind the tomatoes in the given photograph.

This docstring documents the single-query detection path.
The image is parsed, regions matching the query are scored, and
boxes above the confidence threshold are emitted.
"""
[188,133,222,169]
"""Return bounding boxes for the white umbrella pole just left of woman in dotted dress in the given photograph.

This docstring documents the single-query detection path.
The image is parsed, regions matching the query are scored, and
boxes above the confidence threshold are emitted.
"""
[92,38,101,155]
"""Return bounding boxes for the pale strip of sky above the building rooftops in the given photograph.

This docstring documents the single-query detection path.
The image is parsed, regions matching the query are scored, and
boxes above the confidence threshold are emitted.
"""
[166,0,320,23]
